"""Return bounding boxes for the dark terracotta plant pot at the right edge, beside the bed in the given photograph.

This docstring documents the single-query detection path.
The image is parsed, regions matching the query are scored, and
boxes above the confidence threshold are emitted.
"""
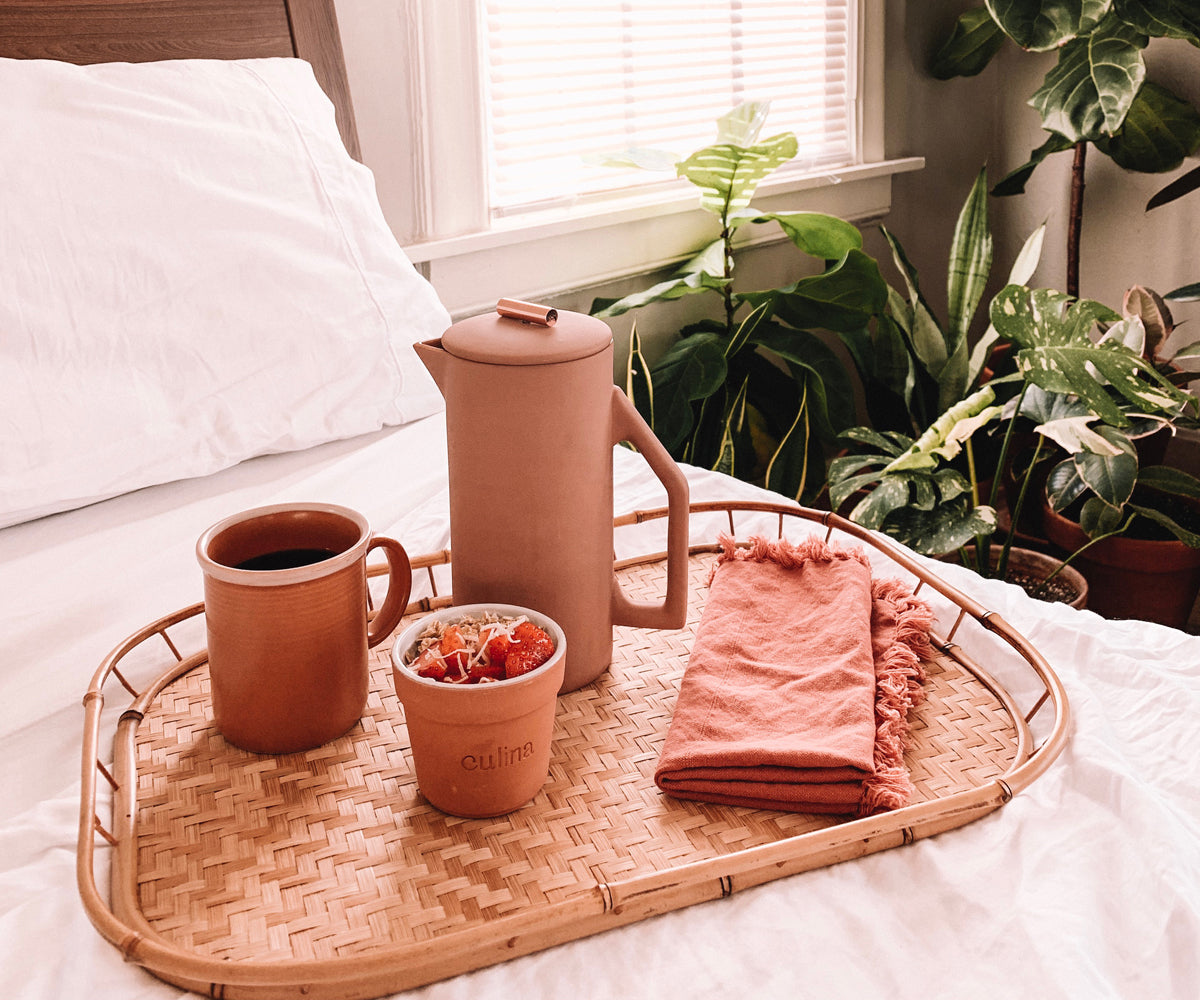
[1043,504,1200,629]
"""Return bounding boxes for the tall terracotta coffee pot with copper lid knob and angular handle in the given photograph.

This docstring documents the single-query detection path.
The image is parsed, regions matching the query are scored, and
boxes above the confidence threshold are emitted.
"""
[414,299,688,691]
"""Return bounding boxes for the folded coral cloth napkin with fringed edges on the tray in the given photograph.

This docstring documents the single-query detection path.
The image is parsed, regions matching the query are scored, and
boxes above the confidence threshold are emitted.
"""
[654,535,932,815]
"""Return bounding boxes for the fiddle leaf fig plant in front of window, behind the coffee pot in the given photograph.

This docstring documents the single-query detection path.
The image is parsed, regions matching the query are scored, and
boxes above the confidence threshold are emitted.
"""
[592,102,887,501]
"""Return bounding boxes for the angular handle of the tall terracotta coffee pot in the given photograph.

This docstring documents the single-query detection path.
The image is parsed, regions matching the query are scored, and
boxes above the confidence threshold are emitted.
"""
[612,385,689,629]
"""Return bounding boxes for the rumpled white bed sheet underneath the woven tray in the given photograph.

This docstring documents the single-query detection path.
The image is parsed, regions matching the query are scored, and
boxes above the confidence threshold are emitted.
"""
[0,417,1200,1000]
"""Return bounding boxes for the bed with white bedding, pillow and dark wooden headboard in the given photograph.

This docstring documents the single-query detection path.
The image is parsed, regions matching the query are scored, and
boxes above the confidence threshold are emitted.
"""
[0,0,1200,1000]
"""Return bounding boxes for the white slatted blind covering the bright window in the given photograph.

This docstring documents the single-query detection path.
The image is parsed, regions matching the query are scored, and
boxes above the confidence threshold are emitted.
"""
[479,0,857,218]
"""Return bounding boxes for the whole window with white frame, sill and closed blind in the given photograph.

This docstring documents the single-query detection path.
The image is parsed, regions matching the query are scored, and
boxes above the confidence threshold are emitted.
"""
[385,0,920,317]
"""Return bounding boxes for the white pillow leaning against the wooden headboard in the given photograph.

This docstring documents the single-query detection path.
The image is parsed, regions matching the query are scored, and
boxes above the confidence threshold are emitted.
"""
[0,59,450,527]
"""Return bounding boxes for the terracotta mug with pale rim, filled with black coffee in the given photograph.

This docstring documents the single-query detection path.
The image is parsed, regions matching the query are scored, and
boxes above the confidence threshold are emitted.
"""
[196,503,413,754]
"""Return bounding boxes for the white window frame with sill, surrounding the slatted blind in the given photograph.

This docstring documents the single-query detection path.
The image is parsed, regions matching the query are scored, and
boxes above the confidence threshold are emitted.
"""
[392,0,924,319]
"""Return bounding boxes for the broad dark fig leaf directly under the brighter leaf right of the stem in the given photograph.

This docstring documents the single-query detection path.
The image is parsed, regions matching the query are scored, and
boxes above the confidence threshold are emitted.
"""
[740,250,887,331]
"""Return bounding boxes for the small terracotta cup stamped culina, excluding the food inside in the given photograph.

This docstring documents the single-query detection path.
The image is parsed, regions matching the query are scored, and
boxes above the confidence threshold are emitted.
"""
[391,604,566,818]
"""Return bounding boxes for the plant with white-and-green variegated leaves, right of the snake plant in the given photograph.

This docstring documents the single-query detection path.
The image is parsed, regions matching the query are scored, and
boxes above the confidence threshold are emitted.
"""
[830,278,1200,609]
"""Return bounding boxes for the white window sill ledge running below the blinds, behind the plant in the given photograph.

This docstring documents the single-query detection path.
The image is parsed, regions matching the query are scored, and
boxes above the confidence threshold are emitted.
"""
[404,157,924,319]
